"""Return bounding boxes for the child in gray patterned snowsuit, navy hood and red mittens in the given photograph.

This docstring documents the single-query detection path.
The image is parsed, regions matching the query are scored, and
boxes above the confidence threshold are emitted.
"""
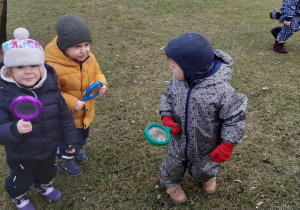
[160,33,247,203]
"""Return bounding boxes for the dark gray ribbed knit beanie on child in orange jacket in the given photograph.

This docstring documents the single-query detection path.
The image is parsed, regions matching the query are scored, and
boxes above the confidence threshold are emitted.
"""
[56,15,92,50]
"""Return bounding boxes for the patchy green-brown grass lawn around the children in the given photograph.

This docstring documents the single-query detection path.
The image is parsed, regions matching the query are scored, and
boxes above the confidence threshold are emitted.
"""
[0,0,300,210]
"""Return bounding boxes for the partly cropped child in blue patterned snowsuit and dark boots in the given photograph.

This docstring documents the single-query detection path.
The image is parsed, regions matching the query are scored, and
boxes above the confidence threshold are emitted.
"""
[270,0,300,53]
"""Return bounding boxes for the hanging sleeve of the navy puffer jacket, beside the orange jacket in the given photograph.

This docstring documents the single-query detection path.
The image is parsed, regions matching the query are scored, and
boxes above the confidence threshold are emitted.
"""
[58,96,78,145]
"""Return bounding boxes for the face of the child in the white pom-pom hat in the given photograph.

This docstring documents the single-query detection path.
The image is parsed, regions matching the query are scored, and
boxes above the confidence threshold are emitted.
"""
[11,65,42,87]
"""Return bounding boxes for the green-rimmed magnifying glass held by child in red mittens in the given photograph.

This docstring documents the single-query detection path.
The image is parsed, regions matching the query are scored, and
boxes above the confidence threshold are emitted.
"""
[144,123,172,146]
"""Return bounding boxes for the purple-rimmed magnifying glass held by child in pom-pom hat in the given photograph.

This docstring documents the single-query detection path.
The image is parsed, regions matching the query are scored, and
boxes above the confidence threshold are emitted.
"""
[10,96,43,122]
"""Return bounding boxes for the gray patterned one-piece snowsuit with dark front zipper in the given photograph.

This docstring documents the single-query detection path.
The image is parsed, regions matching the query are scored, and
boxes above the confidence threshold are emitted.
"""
[160,49,247,188]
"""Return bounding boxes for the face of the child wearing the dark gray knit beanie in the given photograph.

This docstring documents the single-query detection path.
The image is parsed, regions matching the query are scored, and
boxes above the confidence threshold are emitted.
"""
[65,42,90,61]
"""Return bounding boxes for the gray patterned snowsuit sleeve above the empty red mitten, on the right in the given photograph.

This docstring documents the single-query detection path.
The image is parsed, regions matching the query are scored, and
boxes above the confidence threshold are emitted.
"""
[219,84,248,145]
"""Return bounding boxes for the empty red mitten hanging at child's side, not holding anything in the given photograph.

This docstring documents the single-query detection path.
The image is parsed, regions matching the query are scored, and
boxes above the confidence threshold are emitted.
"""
[209,142,234,163]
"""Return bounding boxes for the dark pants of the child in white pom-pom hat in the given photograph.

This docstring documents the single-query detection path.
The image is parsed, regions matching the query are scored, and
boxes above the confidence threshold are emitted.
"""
[5,154,57,198]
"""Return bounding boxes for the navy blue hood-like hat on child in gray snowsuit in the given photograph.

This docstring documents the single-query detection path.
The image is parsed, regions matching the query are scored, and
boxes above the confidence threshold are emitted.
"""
[165,32,214,84]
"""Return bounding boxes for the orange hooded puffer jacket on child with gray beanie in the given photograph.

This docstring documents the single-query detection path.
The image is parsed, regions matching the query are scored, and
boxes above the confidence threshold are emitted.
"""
[45,37,107,129]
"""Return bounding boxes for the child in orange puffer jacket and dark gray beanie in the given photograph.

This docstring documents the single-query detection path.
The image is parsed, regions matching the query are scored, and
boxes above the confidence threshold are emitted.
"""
[45,15,107,176]
